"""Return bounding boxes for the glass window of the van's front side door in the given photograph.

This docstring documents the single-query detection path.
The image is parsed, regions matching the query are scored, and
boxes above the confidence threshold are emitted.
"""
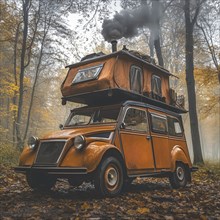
[124,108,148,132]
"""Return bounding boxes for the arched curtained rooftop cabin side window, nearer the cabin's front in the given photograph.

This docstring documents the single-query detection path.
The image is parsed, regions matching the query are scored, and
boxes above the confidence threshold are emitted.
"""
[130,65,143,93]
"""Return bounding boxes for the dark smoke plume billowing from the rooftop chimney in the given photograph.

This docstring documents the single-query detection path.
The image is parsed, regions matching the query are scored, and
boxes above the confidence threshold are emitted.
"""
[102,5,151,42]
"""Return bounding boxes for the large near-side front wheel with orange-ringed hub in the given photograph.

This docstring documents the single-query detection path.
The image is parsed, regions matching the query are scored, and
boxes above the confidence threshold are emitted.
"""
[94,156,124,197]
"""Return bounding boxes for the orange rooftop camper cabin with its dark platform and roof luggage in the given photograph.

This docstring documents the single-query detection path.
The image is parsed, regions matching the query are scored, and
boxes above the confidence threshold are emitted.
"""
[61,46,185,113]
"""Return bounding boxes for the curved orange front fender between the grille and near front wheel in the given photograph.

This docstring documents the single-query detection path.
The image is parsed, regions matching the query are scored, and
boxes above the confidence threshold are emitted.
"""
[60,141,118,173]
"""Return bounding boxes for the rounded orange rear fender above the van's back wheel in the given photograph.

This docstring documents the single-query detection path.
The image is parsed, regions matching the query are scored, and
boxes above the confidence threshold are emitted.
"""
[171,145,191,172]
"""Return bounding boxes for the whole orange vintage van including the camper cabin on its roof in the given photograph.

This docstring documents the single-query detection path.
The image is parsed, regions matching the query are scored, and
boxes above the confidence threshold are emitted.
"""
[15,47,195,196]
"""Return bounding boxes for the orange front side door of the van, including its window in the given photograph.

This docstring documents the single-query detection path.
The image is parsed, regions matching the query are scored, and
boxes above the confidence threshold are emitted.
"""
[120,107,154,174]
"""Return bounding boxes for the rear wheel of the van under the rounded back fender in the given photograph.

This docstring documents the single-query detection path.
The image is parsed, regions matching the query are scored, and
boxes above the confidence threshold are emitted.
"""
[169,163,188,189]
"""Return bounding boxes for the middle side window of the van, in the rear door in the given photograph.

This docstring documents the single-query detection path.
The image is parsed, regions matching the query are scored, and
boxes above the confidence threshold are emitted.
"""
[151,114,167,134]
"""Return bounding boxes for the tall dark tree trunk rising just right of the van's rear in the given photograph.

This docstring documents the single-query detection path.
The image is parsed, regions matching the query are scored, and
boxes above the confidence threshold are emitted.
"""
[184,0,204,164]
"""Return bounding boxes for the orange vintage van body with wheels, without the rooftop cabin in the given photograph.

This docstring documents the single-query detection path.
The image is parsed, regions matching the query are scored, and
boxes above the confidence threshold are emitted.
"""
[15,101,193,196]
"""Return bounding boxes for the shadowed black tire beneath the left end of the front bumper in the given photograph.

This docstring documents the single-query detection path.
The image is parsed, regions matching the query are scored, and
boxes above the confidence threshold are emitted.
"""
[26,173,56,191]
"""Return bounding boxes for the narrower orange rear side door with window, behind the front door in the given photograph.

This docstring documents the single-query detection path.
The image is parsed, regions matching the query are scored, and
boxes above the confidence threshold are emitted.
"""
[149,111,172,170]
